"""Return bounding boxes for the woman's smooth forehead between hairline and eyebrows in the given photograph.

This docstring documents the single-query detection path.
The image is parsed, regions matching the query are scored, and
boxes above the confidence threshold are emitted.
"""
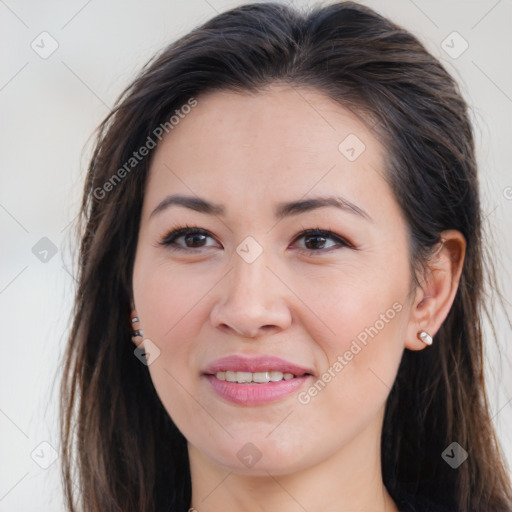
[145,85,392,220]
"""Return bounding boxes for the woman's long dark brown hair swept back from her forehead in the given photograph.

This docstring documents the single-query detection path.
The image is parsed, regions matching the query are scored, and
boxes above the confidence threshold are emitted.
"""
[61,2,512,512]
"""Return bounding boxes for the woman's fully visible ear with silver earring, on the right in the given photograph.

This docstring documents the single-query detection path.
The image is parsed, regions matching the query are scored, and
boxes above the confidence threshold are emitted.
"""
[405,229,466,350]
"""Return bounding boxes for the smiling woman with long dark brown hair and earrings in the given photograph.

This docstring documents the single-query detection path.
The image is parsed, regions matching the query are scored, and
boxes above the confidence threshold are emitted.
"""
[62,2,512,512]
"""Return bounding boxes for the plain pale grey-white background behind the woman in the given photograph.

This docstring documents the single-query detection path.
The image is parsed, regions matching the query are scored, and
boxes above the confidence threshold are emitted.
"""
[0,0,512,512]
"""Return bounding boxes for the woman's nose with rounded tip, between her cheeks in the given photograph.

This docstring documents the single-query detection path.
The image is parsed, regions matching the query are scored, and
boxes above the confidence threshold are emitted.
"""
[210,251,292,338]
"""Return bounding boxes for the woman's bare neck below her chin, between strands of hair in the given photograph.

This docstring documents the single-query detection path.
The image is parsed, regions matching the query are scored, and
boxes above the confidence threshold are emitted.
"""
[188,412,398,512]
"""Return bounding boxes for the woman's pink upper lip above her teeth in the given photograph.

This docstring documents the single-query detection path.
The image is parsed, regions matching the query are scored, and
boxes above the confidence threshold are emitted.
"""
[203,355,314,377]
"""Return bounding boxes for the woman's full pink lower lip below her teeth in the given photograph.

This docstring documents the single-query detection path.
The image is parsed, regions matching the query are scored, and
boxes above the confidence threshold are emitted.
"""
[205,375,312,405]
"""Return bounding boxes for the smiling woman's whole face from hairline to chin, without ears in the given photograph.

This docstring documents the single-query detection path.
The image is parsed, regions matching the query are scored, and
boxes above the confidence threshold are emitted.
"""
[133,86,418,474]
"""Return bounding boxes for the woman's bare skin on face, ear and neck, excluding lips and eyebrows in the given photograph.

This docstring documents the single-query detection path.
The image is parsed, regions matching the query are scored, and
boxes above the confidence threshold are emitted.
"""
[133,85,465,512]
